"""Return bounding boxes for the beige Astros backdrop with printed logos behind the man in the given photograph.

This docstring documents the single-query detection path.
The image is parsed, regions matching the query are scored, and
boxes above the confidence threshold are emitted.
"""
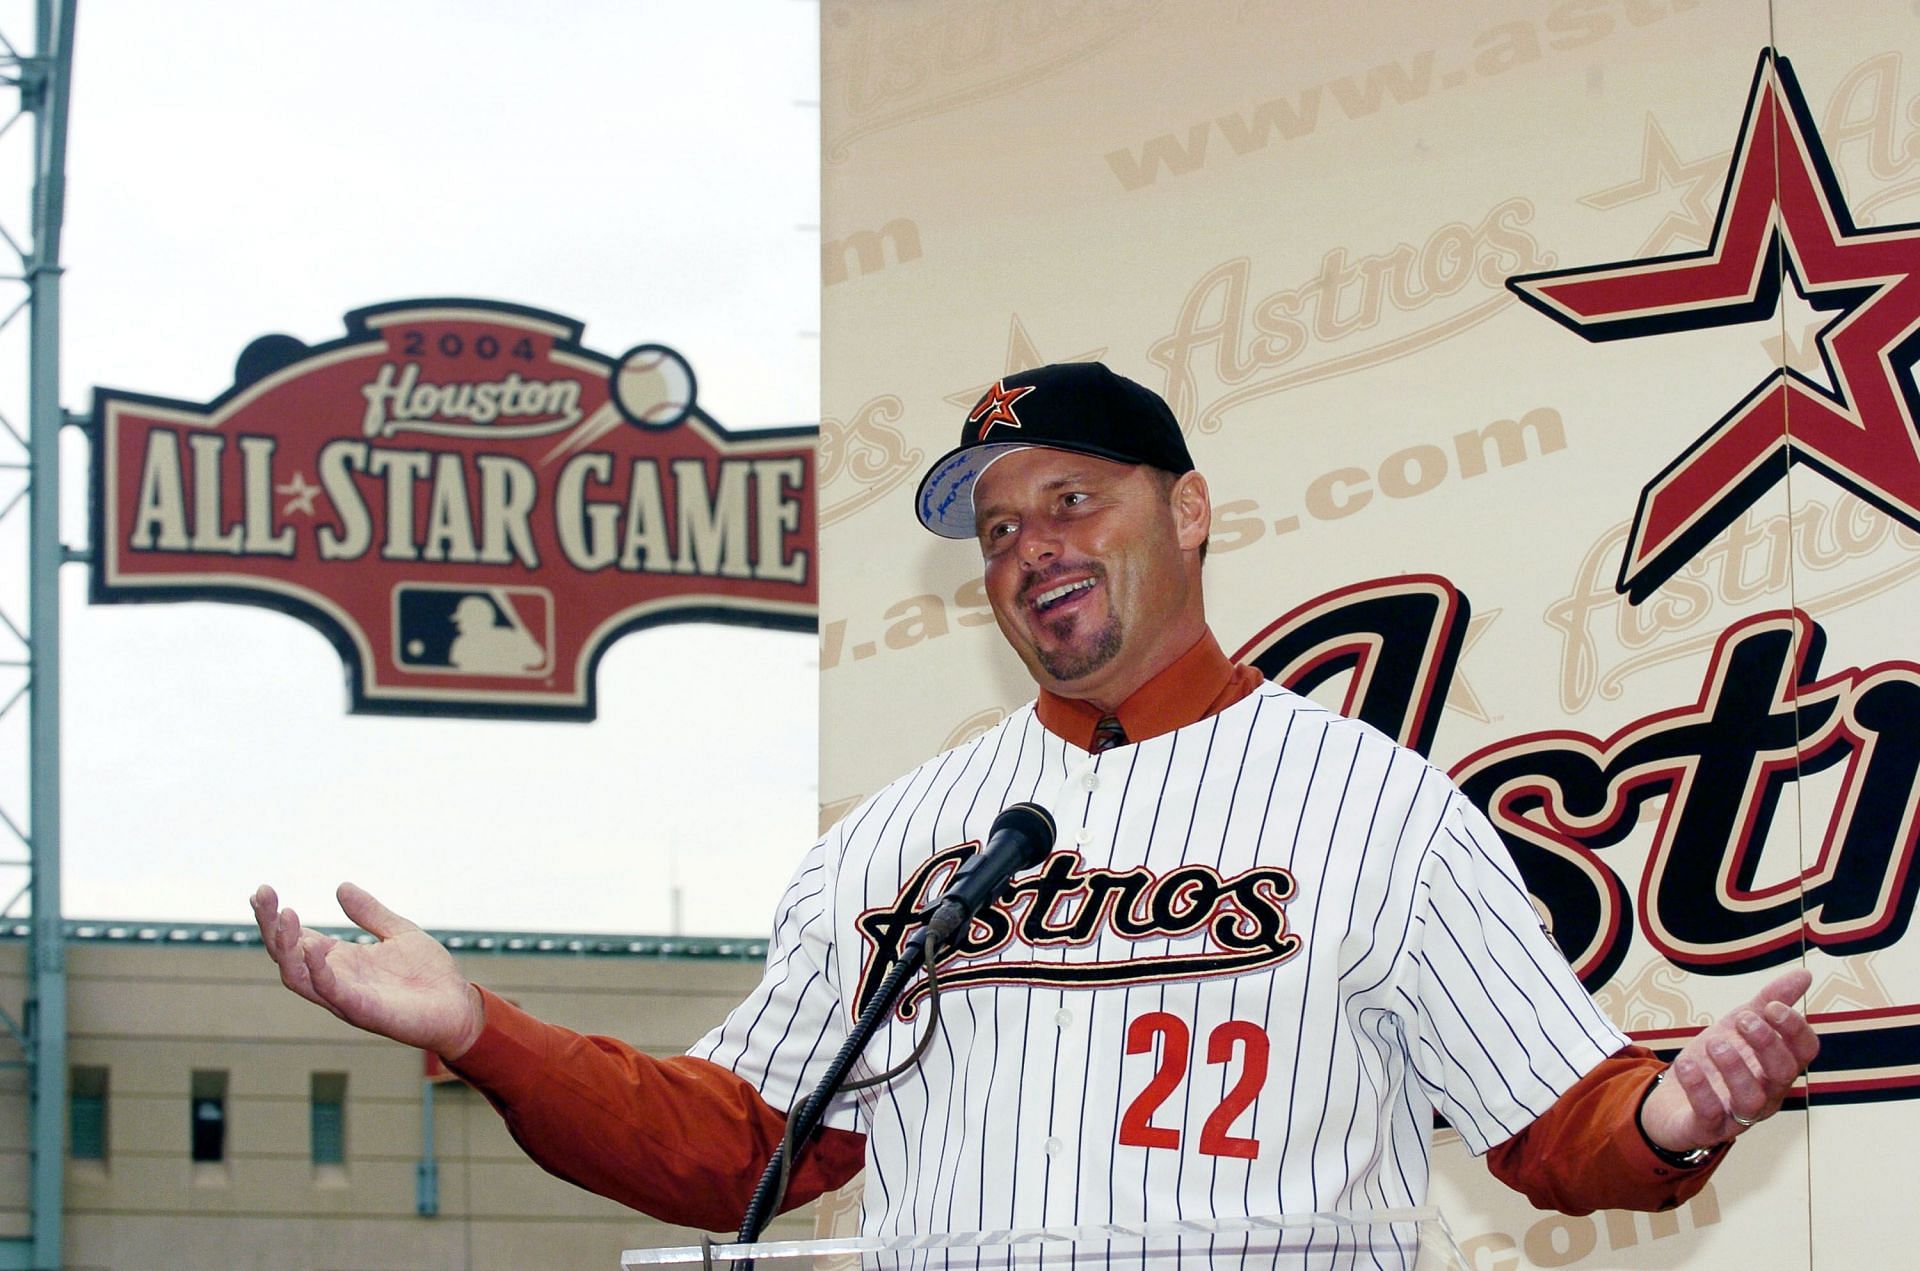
[820,0,1920,1269]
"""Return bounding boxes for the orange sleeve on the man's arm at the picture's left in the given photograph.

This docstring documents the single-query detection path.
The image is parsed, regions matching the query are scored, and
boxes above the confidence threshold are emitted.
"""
[447,989,866,1233]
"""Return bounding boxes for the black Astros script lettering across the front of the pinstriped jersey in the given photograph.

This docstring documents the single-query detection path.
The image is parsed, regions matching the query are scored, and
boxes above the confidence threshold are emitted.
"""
[856,843,1300,1019]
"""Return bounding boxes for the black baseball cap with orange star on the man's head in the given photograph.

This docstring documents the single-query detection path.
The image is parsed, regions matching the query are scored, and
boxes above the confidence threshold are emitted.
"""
[914,361,1194,538]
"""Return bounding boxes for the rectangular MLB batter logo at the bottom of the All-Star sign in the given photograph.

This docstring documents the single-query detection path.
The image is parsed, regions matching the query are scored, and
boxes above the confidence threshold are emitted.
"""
[394,584,553,676]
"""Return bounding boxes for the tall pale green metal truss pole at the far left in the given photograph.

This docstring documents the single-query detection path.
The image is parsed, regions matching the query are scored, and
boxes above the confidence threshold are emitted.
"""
[21,0,75,1267]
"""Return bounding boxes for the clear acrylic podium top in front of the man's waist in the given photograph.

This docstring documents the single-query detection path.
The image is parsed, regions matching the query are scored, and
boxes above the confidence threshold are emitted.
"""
[620,1208,1471,1271]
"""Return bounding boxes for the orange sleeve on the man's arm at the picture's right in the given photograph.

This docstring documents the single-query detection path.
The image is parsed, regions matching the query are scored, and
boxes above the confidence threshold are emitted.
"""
[1486,1046,1726,1213]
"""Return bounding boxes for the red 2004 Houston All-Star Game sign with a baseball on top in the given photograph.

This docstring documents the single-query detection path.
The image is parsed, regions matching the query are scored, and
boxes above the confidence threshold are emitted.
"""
[92,300,816,720]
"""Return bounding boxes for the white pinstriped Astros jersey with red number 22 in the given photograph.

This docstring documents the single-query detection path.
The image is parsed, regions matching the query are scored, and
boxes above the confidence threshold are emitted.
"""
[693,683,1626,1259]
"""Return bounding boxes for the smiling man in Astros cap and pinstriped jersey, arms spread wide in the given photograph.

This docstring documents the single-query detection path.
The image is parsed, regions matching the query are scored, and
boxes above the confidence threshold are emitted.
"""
[255,363,1818,1256]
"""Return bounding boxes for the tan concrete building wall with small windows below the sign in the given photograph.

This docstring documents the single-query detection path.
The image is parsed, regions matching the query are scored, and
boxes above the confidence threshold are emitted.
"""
[0,931,812,1271]
